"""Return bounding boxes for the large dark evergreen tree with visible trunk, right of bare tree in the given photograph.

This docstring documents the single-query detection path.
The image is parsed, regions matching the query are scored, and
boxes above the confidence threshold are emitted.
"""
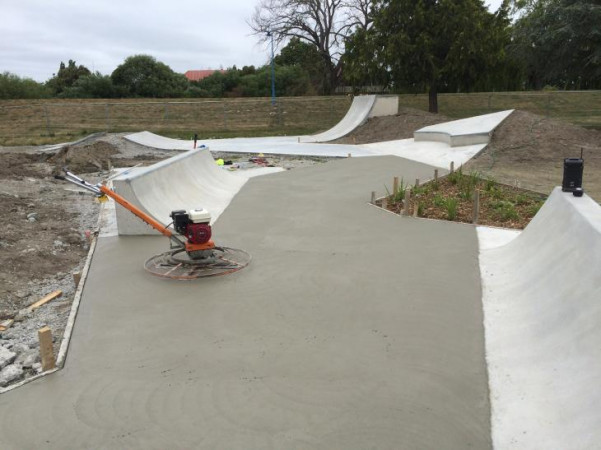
[349,0,509,112]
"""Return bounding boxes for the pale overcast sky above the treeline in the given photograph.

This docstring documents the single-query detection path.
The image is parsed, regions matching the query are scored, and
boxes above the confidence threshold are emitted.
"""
[0,0,501,81]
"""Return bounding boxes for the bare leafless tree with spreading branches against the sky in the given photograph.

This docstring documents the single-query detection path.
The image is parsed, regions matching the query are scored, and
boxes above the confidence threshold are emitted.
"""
[249,0,371,94]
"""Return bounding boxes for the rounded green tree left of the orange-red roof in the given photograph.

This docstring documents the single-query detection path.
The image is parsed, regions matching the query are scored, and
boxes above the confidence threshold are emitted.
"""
[111,55,188,97]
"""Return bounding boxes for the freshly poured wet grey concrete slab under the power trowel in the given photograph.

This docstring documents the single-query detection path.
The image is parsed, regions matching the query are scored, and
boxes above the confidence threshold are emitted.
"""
[0,157,491,450]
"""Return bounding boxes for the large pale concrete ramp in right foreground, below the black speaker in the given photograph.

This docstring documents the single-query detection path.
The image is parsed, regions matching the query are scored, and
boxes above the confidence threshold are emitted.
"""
[480,188,601,449]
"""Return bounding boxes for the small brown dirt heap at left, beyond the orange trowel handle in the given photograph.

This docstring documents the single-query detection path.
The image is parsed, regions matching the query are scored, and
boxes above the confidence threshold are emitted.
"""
[49,141,120,174]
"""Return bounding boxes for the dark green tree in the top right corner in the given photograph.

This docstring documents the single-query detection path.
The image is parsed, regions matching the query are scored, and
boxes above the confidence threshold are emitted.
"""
[509,0,601,89]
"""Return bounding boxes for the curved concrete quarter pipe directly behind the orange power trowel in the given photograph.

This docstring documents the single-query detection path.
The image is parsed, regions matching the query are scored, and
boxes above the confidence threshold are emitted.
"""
[113,149,247,235]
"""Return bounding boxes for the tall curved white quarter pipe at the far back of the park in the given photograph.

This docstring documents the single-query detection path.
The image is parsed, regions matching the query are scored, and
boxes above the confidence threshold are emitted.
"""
[299,95,399,142]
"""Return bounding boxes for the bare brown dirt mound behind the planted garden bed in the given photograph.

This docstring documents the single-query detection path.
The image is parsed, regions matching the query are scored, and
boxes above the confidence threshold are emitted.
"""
[465,111,601,201]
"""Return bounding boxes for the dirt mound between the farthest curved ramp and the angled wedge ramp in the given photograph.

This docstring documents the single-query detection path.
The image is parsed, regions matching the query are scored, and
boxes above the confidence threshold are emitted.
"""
[332,108,452,144]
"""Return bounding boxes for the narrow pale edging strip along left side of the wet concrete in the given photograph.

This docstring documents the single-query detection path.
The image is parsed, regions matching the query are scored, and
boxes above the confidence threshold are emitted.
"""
[0,204,105,395]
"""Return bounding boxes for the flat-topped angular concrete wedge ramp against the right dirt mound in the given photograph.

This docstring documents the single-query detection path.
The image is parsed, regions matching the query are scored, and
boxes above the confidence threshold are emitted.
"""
[413,109,513,147]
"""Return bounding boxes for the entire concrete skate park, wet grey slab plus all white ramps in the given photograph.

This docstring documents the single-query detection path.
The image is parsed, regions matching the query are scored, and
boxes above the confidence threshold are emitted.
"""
[0,97,601,449]
